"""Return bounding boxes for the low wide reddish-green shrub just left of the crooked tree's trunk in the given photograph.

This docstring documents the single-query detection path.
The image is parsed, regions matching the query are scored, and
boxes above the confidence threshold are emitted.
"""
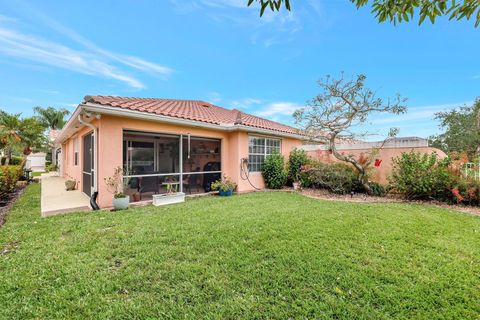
[300,162,359,194]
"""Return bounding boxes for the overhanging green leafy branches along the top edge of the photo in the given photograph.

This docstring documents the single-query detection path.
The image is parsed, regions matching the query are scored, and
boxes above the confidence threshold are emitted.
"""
[248,0,480,27]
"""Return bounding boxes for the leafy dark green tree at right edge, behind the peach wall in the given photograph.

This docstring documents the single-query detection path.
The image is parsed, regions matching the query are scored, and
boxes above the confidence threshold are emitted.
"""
[430,98,480,161]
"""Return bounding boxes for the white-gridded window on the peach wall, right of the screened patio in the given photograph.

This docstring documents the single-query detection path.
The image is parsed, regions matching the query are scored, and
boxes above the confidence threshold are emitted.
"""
[248,136,280,172]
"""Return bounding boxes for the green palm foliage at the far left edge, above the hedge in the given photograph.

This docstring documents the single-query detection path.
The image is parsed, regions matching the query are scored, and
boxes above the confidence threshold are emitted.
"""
[0,110,45,165]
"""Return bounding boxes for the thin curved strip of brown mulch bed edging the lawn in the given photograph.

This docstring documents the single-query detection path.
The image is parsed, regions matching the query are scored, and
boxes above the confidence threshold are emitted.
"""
[300,189,480,216]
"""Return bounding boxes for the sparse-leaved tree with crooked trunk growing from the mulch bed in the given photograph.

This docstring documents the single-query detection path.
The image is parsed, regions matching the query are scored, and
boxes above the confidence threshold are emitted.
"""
[294,75,407,193]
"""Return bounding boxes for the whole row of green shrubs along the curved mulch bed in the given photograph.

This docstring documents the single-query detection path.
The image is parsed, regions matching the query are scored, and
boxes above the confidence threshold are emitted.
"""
[262,149,480,206]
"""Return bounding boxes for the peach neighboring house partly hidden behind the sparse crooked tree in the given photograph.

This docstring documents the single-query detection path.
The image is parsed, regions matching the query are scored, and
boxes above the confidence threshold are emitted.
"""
[302,137,447,183]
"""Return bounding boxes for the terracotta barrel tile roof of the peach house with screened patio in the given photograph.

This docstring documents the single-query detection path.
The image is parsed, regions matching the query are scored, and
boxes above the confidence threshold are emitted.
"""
[85,96,297,134]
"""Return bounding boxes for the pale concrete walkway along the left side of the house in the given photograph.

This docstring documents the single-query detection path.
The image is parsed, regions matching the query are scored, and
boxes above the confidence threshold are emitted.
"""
[40,173,90,217]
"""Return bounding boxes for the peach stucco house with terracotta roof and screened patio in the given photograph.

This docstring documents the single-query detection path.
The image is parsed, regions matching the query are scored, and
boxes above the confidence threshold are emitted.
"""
[55,96,302,207]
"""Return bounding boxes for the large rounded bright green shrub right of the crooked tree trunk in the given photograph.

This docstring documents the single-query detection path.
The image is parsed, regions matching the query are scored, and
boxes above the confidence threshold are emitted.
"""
[389,151,455,201]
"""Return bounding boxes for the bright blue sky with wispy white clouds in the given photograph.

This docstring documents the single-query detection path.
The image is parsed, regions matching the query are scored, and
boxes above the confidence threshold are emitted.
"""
[0,0,480,139]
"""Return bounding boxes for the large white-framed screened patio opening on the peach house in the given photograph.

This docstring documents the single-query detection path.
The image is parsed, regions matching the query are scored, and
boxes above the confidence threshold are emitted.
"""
[123,131,221,201]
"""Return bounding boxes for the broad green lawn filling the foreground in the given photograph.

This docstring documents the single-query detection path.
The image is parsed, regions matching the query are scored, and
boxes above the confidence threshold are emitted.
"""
[0,185,480,319]
